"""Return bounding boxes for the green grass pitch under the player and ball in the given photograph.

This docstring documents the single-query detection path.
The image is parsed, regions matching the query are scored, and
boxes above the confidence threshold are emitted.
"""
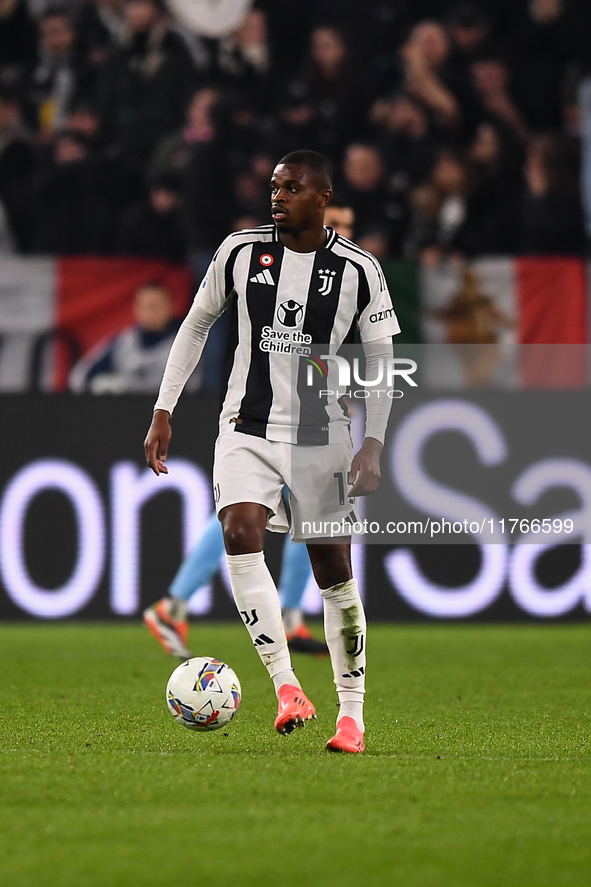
[0,624,591,887]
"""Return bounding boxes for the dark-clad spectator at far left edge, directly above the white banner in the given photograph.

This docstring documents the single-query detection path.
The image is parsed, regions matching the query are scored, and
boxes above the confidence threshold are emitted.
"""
[0,89,36,252]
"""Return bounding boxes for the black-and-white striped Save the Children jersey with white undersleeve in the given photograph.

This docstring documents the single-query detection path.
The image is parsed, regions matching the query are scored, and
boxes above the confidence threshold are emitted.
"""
[155,225,400,444]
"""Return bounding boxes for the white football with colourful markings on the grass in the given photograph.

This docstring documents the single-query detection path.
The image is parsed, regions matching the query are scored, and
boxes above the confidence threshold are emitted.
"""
[166,656,242,730]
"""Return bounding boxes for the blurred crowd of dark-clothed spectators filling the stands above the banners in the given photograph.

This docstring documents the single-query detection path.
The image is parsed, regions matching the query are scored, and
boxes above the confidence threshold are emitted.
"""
[0,0,591,275]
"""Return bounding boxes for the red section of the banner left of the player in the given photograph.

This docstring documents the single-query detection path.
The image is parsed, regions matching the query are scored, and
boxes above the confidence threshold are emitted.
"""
[53,257,194,391]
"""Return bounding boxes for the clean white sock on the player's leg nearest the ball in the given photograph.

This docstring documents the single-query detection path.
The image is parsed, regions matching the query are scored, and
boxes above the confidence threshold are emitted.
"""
[226,551,300,693]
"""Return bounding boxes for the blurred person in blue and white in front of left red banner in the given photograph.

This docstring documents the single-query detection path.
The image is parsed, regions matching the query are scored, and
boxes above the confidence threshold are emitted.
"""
[70,282,198,394]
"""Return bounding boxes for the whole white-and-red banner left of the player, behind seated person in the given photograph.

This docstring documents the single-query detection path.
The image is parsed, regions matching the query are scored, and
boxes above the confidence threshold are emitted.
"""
[0,257,193,392]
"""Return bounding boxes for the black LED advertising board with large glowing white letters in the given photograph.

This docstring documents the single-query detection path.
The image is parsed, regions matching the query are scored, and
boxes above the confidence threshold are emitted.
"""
[0,391,591,621]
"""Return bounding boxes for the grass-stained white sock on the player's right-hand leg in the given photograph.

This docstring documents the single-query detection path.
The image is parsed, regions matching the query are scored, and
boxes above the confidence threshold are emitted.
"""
[320,579,367,731]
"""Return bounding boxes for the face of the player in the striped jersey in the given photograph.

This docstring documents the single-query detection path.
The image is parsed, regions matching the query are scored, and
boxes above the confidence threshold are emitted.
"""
[271,163,332,233]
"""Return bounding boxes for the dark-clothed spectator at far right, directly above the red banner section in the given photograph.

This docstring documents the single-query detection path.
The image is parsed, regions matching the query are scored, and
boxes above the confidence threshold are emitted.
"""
[518,136,585,256]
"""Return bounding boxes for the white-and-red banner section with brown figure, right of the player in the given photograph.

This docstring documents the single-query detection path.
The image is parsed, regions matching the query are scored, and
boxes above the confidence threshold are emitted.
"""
[419,257,589,388]
